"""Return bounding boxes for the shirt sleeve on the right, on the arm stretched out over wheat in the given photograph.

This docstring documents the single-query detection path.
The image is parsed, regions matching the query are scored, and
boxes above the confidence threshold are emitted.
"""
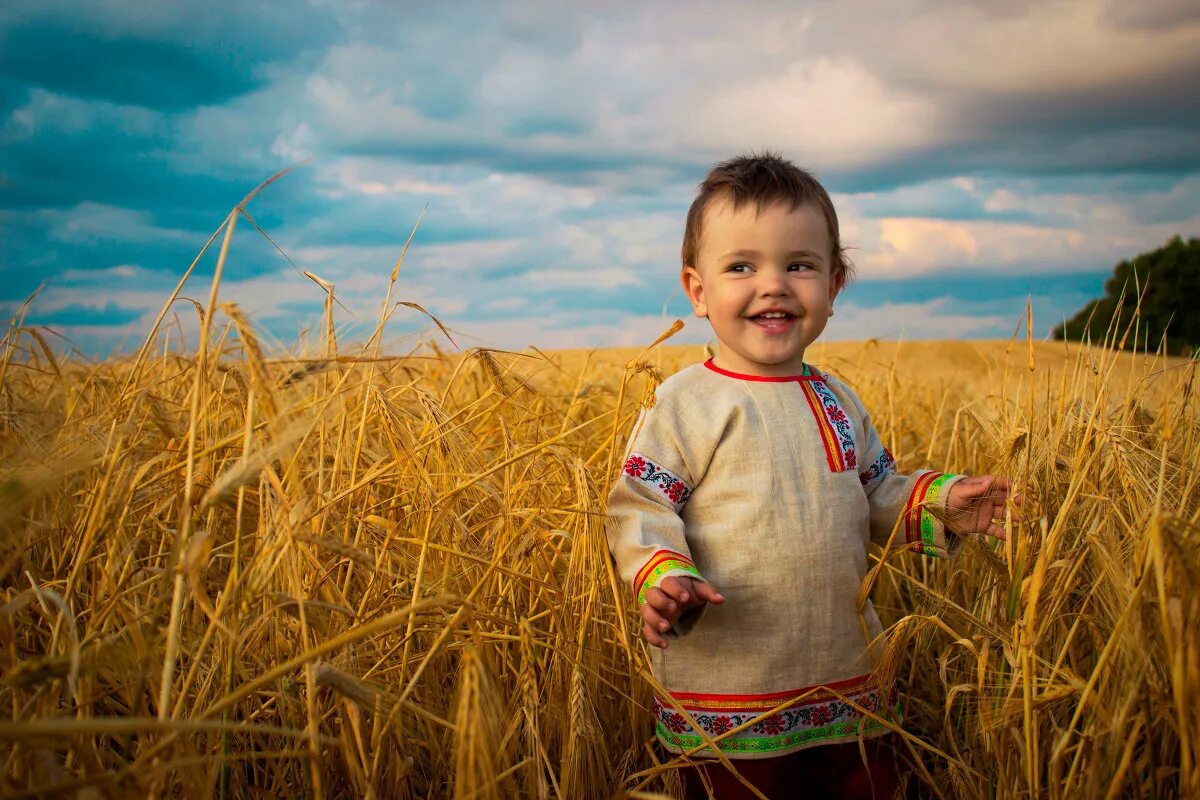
[839,381,962,558]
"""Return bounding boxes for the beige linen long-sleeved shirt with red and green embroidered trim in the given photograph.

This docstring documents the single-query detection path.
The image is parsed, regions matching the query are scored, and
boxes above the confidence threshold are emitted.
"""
[607,360,959,758]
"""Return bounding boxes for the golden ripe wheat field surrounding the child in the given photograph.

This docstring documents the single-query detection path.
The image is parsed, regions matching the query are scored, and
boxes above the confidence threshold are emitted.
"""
[0,209,1200,800]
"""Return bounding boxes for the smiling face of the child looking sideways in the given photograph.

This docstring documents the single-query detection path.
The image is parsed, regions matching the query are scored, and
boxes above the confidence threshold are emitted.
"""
[682,198,842,377]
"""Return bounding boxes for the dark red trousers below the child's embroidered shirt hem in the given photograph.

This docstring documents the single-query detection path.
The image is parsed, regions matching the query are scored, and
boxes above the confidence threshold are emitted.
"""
[682,734,900,800]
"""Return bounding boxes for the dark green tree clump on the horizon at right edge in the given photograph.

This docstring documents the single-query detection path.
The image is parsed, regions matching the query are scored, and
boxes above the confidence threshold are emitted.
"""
[1054,236,1200,354]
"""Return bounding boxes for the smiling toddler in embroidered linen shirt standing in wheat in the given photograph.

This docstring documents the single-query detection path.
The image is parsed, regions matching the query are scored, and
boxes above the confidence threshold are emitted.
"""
[607,154,1009,800]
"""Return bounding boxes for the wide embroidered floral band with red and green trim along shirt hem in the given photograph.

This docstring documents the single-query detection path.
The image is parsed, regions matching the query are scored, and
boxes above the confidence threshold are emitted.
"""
[654,675,900,753]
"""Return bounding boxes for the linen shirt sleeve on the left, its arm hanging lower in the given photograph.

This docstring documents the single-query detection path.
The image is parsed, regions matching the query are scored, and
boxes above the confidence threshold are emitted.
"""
[605,388,704,633]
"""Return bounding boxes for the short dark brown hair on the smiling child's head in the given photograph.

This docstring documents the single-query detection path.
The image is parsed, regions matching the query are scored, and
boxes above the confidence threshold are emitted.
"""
[682,152,852,282]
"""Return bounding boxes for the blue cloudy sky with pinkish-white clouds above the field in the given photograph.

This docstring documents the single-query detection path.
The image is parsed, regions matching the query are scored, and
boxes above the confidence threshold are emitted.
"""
[0,0,1200,354]
